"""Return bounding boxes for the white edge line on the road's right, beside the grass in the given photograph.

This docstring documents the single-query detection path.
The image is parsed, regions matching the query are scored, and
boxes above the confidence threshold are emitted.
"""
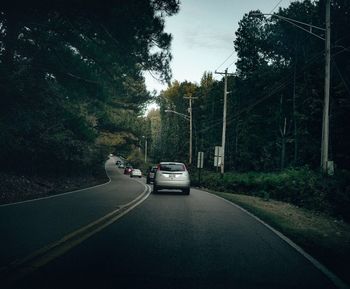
[197,189,350,289]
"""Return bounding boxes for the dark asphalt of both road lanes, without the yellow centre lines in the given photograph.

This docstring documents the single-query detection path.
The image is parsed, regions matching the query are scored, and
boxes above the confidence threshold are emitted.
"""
[0,158,335,289]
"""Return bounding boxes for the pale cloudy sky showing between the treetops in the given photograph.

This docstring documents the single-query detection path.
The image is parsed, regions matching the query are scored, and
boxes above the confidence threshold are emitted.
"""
[145,0,294,92]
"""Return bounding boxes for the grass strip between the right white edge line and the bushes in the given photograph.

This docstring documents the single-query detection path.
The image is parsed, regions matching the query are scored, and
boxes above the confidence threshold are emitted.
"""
[206,191,350,284]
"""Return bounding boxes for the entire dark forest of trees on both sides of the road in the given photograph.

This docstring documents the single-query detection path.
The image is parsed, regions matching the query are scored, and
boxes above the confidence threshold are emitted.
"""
[0,0,350,181]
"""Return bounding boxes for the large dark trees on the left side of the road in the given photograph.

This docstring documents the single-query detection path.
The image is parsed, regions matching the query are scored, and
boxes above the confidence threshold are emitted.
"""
[0,0,179,174]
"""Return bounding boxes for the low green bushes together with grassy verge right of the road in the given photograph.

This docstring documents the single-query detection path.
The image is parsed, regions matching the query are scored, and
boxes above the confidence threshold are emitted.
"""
[186,167,350,284]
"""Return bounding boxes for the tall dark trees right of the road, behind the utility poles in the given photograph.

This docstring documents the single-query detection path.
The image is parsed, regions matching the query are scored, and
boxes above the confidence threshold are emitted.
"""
[153,0,350,171]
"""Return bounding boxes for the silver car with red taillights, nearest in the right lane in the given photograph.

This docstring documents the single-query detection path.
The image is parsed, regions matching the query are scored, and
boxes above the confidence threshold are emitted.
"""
[153,162,190,195]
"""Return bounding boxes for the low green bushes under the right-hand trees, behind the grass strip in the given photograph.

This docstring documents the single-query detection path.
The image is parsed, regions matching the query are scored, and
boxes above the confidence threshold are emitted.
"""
[192,167,350,220]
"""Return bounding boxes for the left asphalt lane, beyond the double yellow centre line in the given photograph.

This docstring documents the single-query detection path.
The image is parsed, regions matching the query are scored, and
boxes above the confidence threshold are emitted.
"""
[0,158,145,268]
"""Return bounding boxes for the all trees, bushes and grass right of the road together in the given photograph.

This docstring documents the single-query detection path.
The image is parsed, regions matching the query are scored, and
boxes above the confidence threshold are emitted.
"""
[145,0,350,283]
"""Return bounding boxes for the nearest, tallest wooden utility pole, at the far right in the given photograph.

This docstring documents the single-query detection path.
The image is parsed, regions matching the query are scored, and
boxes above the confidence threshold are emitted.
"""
[321,0,331,174]
